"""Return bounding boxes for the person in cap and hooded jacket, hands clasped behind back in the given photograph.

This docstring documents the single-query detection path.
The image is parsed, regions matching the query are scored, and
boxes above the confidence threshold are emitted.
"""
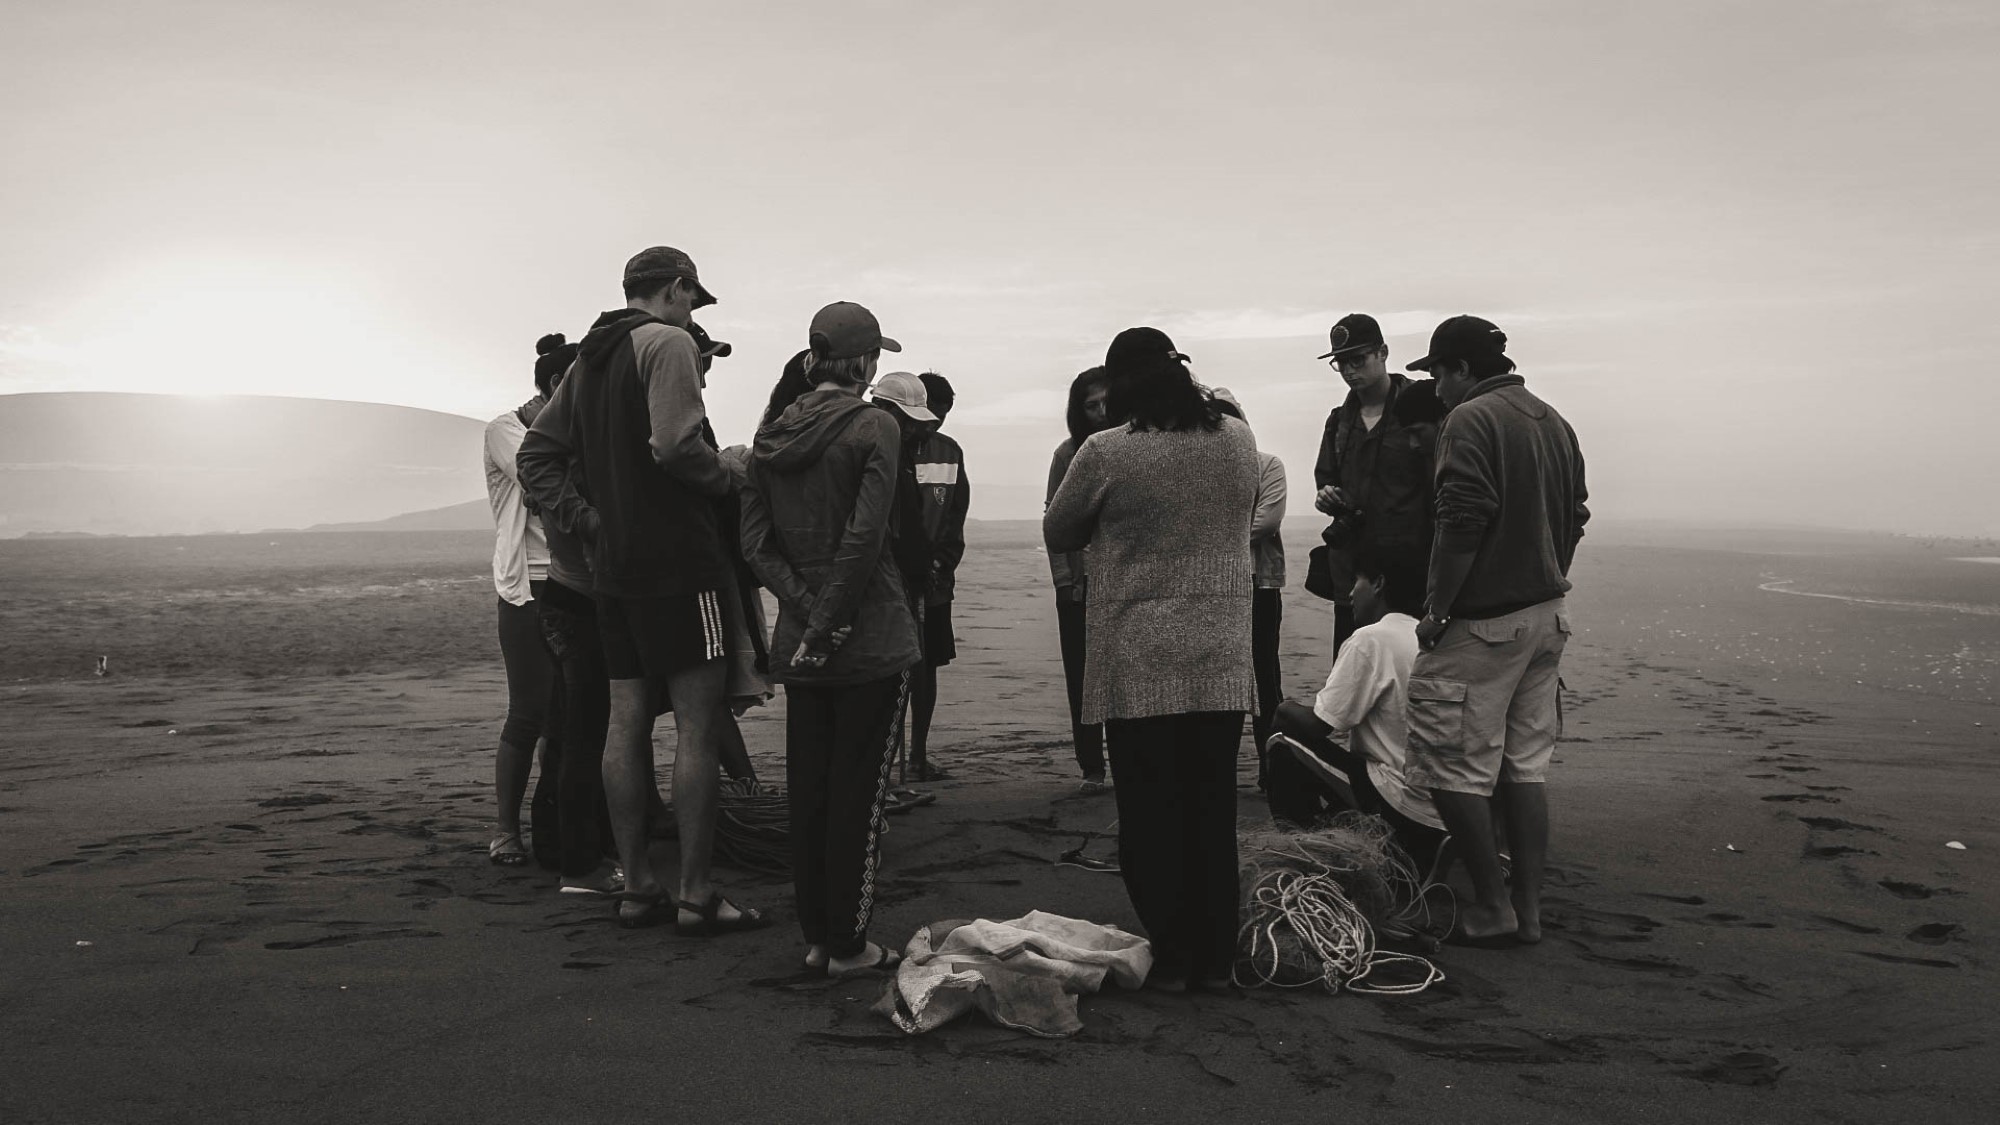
[742,302,920,977]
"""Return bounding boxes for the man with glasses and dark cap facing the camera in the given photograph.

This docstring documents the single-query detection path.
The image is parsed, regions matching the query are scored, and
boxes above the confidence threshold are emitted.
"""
[1306,312,1438,657]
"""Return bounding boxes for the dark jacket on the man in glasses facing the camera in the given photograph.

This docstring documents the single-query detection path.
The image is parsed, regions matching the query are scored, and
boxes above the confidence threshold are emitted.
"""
[1312,374,1438,601]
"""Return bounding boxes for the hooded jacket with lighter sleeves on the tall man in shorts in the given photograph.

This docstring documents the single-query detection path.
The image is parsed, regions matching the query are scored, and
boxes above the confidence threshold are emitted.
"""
[516,308,734,597]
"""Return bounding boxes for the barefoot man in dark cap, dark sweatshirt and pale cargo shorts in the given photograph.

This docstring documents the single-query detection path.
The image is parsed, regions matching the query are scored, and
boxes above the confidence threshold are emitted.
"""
[1408,316,1590,947]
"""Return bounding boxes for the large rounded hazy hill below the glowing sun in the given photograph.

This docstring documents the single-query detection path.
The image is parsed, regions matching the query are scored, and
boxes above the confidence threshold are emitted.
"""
[0,392,486,536]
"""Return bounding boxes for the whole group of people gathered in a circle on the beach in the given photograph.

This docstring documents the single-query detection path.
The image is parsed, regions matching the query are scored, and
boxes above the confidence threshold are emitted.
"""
[486,246,1588,987]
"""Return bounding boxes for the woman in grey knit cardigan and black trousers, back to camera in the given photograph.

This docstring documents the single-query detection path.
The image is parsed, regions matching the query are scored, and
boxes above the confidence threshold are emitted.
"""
[1042,328,1258,989]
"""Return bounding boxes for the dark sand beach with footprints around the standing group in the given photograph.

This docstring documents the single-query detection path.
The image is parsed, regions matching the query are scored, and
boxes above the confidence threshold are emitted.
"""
[0,524,2000,1125]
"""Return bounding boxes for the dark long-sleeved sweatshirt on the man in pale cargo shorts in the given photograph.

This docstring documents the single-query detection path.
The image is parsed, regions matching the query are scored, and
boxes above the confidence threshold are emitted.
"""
[1438,374,1590,619]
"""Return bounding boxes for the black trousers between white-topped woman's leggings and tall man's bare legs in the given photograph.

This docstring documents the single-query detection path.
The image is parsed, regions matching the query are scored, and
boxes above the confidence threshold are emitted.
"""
[534,581,612,877]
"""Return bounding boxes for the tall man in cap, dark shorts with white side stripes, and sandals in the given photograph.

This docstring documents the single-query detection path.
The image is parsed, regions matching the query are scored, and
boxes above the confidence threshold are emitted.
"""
[518,246,766,935]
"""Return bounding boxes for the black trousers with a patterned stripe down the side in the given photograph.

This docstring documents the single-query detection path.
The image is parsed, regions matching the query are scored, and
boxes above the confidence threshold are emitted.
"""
[784,675,908,957]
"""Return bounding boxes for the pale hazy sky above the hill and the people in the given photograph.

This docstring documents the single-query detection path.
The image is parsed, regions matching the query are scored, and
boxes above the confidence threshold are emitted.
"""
[0,0,2000,534]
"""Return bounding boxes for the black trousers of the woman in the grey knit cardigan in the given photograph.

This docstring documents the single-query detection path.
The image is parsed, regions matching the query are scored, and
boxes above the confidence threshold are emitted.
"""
[1104,711,1244,979]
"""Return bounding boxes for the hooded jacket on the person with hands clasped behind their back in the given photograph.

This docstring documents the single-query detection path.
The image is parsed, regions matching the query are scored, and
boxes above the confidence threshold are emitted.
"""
[742,390,918,685]
